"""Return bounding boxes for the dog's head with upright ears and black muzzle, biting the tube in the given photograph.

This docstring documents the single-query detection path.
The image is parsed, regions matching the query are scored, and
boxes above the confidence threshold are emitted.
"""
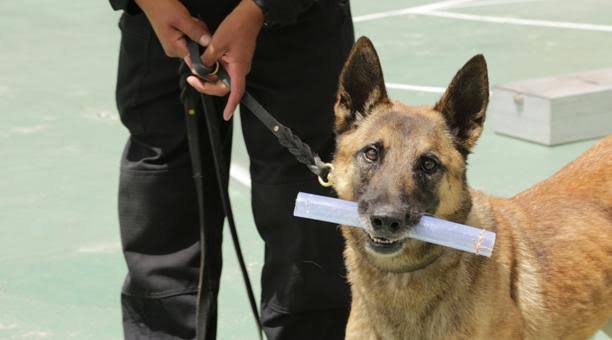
[334,37,489,272]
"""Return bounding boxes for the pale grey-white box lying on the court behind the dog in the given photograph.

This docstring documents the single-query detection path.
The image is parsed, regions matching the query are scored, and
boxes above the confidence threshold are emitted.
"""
[487,69,612,145]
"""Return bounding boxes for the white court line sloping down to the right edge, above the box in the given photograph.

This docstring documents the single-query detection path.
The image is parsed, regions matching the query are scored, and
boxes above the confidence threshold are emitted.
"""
[414,11,612,32]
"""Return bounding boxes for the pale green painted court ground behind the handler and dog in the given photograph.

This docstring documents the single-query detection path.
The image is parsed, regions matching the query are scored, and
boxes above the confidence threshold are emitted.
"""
[0,0,612,339]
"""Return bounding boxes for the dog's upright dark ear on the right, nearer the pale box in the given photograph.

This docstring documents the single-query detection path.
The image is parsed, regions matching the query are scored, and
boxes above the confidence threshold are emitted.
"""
[434,54,489,155]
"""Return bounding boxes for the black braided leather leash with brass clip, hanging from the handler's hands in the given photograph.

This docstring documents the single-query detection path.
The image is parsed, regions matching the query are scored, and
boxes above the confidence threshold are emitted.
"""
[180,40,332,340]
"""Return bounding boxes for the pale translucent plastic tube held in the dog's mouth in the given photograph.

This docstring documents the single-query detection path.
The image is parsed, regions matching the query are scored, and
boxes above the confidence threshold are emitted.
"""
[293,192,495,257]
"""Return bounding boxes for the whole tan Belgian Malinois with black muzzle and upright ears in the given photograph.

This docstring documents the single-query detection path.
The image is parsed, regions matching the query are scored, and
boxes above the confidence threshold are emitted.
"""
[334,38,612,339]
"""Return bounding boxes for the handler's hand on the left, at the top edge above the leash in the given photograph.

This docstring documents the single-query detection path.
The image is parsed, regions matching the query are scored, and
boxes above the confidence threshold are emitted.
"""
[135,0,210,58]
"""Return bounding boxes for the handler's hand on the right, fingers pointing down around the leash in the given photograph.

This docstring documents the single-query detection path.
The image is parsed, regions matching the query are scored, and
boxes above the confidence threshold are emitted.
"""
[184,0,264,120]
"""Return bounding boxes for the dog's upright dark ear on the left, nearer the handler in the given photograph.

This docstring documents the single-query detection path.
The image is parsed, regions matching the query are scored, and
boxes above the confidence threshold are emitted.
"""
[334,37,390,134]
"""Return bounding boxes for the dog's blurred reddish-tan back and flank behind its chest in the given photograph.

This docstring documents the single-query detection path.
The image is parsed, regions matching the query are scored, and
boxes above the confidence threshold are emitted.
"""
[510,136,612,338]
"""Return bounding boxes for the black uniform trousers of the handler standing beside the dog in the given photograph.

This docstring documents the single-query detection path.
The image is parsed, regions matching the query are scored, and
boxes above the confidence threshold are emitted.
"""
[117,0,354,339]
